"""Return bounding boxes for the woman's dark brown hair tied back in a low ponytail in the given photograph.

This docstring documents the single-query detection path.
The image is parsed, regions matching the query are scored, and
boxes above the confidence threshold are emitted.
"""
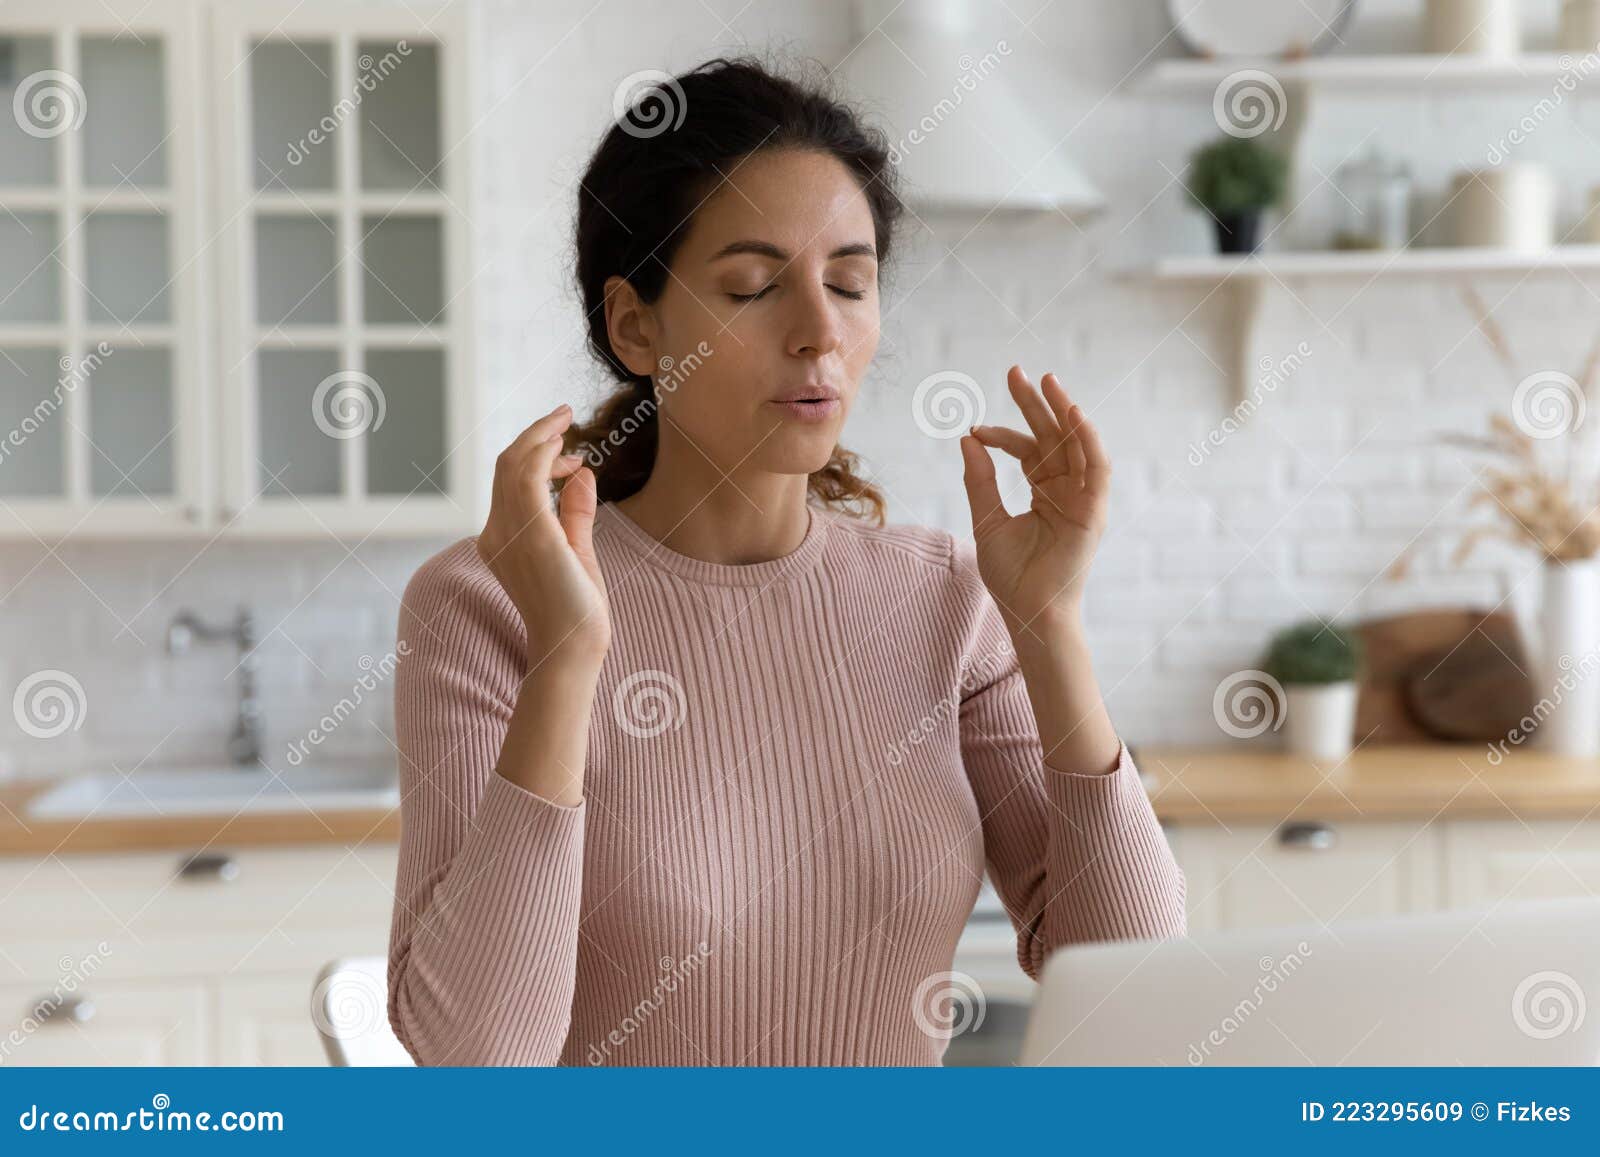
[563,58,901,523]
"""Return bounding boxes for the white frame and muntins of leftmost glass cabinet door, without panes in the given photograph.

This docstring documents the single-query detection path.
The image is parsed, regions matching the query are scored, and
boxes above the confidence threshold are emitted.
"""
[0,0,214,541]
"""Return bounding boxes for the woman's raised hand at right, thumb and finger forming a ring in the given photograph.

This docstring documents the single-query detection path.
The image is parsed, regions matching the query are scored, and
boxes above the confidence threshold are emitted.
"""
[962,366,1110,640]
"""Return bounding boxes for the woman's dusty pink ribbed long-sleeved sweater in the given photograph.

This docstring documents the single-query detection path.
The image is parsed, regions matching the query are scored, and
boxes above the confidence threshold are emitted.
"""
[389,502,1186,1064]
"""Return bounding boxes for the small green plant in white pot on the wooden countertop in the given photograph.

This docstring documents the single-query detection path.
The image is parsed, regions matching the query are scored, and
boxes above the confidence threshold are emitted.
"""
[1261,619,1363,760]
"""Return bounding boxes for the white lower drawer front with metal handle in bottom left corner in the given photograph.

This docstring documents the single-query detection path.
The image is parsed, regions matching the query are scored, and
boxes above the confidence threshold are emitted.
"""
[0,978,210,1066]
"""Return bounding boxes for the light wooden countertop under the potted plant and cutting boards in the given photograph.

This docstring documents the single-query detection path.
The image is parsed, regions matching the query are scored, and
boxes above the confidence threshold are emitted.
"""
[1131,744,1600,824]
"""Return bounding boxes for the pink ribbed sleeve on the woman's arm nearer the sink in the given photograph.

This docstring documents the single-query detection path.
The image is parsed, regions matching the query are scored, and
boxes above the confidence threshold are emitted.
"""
[389,539,586,1064]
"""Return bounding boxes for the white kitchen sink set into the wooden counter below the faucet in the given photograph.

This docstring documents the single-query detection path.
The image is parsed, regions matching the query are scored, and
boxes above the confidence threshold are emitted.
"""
[26,763,400,819]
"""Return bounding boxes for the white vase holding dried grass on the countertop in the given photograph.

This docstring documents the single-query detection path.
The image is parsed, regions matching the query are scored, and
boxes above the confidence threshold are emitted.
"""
[1533,558,1600,755]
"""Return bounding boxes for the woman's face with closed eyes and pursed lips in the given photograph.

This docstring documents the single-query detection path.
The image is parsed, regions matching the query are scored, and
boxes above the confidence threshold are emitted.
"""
[614,150,878,477]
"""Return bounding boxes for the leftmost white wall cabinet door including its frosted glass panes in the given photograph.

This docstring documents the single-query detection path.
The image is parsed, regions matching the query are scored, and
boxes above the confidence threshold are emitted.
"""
[0,0,214,538]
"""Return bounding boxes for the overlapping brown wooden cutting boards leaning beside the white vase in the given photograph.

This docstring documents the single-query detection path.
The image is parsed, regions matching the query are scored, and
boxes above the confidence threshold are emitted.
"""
[1355,608,1536,744]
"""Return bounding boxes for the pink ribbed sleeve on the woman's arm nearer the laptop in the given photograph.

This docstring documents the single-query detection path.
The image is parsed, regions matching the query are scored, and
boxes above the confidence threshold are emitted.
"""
[952,542,1187,979]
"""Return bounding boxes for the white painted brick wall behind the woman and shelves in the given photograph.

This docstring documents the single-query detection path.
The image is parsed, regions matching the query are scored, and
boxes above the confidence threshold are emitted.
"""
[0,0,1580,768]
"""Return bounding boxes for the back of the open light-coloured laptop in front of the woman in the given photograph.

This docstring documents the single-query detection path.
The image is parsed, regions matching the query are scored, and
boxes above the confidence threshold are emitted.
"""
[1019,898,1600,1066]
